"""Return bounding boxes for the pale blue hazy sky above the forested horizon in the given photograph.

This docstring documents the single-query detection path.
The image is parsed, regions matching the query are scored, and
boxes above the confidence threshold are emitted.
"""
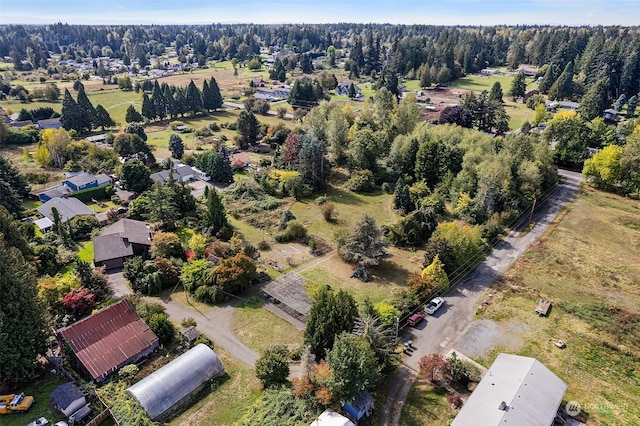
[0,0,640,25]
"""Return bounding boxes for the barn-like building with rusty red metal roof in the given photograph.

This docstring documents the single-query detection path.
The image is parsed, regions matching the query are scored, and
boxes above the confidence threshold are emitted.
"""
[56,299,159,383]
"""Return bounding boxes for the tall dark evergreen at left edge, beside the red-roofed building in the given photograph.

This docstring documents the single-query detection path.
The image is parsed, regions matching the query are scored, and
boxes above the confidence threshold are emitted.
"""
[0,233,47,382]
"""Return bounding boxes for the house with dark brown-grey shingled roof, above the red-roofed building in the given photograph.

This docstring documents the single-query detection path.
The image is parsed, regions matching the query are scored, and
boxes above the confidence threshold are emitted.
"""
[92,219,153,269]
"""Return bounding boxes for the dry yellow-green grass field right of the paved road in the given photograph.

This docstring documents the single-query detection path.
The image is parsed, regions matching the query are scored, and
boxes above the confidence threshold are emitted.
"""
[481,188,640,425]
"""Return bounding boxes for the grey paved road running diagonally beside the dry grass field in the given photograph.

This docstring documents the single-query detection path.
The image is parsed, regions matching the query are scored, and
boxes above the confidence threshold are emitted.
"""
[380,170,582,426]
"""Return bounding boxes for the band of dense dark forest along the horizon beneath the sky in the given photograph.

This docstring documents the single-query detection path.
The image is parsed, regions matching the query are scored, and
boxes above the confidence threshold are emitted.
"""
[0,23,640,99]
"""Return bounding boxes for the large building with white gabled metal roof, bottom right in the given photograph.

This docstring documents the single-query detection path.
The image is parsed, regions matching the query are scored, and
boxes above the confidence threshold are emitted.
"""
[452,354,567,426]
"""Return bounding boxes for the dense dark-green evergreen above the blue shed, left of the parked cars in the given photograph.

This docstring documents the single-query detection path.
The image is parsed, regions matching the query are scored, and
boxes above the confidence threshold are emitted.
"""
[304,286,358,361]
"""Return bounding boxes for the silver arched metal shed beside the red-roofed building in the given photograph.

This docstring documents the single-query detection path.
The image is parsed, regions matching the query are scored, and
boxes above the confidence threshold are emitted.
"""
[127,343,225,421]
